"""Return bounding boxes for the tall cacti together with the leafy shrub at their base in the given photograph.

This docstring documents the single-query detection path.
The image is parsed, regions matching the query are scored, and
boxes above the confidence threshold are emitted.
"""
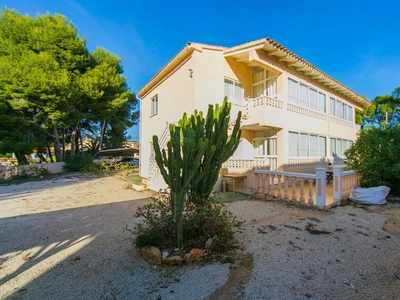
[134,98,241,249]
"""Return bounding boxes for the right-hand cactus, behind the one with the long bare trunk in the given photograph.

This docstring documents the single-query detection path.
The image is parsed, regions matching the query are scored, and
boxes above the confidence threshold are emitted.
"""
[179,97,241,204]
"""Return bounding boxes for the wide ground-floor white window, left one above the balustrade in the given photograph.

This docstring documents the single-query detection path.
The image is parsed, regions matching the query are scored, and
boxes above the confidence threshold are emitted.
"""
[289,131,326,157]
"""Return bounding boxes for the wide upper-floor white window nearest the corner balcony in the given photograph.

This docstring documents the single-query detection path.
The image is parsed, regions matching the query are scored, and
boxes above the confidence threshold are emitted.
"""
[288,78,326,113]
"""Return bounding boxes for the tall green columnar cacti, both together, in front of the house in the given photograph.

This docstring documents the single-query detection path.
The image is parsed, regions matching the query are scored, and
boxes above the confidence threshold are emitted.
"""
[153,97,241,248]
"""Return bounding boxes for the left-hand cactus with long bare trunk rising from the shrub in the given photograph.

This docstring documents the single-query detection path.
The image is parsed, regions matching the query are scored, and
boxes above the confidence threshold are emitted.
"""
[153,125,208,248]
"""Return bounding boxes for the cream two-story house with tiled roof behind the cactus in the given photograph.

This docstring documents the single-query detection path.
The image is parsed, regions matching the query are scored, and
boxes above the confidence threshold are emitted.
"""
[137,38,370,190]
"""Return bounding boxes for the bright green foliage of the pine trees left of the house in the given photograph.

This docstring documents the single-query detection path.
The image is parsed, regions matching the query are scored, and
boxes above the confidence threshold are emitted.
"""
[0,9,138,161]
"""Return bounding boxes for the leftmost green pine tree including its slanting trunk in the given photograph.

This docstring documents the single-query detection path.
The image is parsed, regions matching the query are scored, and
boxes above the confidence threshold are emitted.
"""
[0,9,89,161]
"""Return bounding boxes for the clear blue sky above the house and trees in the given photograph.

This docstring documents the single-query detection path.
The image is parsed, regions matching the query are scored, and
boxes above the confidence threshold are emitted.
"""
[0,0,400,140]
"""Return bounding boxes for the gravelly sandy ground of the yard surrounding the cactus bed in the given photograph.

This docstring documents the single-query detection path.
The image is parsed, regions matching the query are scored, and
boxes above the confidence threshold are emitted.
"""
[0,175,400,299]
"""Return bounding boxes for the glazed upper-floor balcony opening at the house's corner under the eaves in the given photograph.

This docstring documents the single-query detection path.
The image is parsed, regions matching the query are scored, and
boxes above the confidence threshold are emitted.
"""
[251,67,278,98]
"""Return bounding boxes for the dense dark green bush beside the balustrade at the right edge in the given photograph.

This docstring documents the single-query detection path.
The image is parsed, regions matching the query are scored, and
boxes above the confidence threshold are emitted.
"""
[344,126,400,195]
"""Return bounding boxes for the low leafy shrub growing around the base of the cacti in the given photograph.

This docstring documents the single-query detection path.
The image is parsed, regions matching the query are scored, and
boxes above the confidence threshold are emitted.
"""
[132,194,240,252]
